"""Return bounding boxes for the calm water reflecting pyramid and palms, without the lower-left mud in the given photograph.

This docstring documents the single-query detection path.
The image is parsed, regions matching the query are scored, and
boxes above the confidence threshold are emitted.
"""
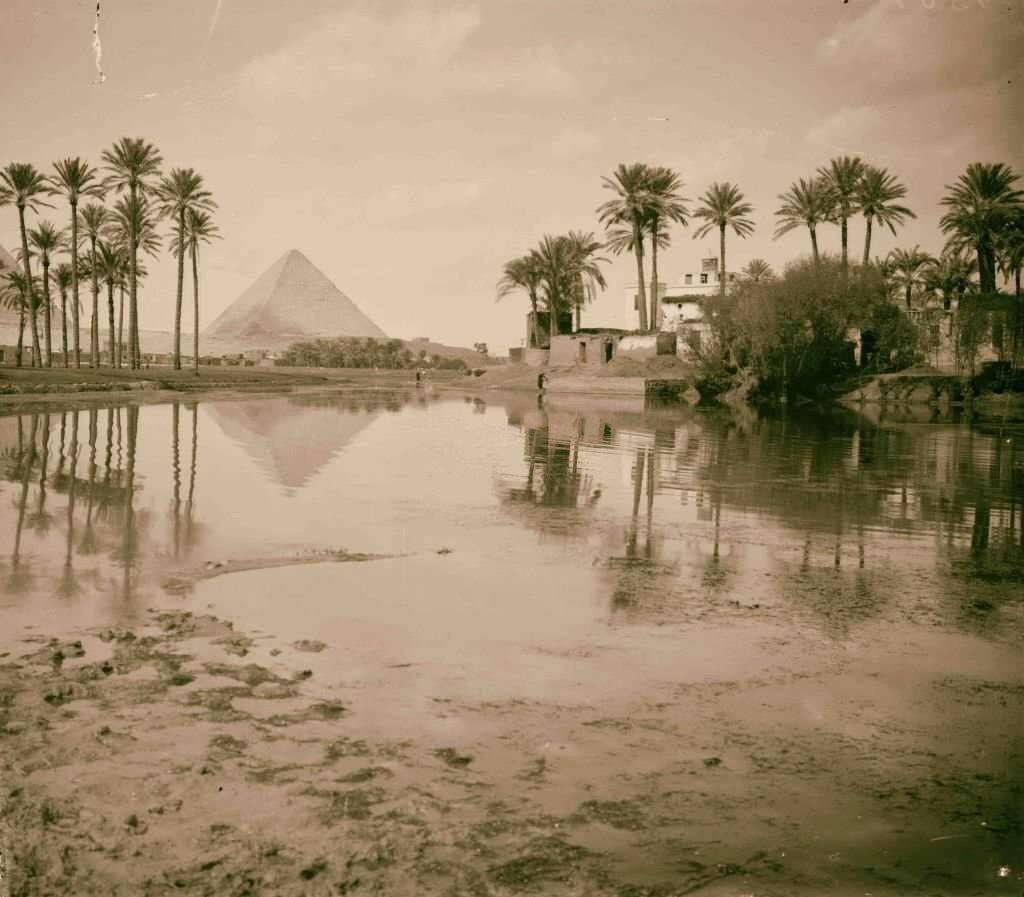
[0,391,1024,895]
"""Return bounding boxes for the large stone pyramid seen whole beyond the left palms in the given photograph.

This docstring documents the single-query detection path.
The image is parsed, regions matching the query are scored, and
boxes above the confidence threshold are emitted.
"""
[203,249,386,349]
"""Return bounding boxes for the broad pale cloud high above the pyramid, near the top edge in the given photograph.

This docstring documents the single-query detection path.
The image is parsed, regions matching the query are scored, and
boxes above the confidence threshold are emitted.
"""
[238,6,577,106]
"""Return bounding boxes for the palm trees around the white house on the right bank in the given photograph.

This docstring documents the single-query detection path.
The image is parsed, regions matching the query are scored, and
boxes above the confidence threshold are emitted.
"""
[498,156,1024,339]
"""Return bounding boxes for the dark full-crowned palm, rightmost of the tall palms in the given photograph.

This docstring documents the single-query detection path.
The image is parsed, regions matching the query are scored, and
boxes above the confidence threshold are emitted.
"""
[939,162,1024,293]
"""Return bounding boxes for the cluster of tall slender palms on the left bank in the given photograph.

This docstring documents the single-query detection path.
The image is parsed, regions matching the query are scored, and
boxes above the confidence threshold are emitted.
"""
[0,137,219,373]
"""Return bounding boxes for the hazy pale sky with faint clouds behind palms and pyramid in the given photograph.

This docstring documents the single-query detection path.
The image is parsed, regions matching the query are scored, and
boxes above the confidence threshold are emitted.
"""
[0,0,1024,353]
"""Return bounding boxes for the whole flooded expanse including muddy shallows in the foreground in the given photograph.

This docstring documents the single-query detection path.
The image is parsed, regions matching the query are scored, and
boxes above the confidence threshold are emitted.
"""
[0,390,1024,897]
